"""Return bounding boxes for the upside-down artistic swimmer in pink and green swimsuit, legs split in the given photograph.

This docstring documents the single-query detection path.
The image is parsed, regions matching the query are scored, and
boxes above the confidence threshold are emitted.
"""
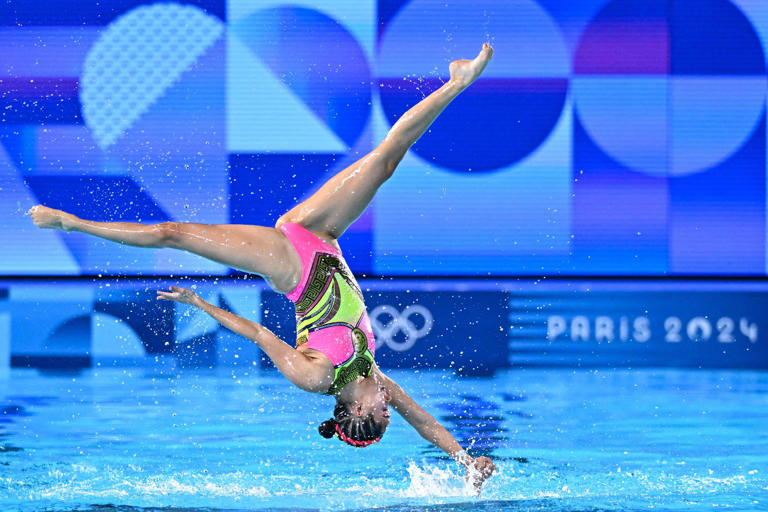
[30,44,496,487]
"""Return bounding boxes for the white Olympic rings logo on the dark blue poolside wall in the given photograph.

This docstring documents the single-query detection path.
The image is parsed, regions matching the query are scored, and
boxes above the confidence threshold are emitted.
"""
[368,304,434,352]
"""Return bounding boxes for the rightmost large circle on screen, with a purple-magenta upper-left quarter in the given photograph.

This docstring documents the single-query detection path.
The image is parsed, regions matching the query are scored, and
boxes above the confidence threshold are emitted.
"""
[572,0,766,176]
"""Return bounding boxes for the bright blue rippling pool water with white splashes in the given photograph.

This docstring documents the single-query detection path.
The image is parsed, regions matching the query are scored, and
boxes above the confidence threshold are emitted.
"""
[0,367,768,511]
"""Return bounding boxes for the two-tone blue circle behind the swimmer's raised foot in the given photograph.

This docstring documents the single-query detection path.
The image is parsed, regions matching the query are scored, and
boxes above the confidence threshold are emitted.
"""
[378,0,570,172]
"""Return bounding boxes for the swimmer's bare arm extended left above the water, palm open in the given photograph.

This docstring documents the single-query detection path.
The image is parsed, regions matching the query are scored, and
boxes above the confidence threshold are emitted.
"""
[157,286,331,393]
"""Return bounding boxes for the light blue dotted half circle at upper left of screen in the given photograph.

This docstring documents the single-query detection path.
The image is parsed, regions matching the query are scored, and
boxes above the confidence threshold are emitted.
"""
[80,3,224,149]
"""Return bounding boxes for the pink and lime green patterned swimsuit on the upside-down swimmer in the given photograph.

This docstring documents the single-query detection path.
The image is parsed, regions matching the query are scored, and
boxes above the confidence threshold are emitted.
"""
[280,223,375,395]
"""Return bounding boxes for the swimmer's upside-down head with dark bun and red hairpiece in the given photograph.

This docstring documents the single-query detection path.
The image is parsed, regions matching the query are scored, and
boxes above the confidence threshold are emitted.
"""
[318,377,390,448]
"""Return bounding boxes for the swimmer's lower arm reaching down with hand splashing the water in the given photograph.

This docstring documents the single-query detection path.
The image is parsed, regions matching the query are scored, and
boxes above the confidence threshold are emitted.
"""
[377,369,496,488]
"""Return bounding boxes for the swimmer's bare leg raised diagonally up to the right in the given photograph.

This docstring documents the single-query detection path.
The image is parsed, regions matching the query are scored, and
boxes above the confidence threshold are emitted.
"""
[277,44,493,239]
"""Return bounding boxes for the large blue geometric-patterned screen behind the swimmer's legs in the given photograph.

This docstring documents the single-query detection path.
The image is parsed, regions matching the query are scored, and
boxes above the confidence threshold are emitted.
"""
[0,0,768,276]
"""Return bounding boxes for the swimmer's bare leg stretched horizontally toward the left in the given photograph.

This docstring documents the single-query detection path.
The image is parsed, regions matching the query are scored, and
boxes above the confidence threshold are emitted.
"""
[30,206,301,292]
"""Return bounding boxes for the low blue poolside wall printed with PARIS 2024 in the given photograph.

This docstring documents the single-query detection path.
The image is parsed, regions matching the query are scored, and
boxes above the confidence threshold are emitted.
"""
[0,278,768,376]
